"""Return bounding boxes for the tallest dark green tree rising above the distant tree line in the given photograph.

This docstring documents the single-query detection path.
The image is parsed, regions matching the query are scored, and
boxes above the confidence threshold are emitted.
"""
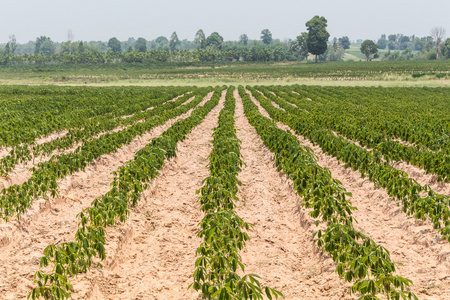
[306,16,330,63]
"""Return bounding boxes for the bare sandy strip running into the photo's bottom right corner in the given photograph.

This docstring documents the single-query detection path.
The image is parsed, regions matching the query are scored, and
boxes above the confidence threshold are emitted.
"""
[246,91,450,299]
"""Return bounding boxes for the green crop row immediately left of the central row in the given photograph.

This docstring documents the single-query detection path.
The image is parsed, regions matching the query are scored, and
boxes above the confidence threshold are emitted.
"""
[28,88,222,299]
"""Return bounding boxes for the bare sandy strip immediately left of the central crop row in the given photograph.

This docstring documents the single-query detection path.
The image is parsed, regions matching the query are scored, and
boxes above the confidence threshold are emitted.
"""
[65,90,225,299]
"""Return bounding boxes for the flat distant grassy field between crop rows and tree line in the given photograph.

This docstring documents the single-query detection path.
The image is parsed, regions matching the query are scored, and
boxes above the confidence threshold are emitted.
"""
[0,59,450,86]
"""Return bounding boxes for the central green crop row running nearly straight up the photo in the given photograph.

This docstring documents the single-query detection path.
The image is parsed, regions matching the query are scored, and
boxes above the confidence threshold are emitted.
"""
[191,87,282,300]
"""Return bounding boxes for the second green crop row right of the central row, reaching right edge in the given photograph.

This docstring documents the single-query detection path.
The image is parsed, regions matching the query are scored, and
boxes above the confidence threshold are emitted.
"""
[250,88,450,242]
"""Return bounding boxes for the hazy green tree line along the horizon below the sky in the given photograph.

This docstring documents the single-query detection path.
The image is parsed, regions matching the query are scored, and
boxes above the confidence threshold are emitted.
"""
[0,16,450,65]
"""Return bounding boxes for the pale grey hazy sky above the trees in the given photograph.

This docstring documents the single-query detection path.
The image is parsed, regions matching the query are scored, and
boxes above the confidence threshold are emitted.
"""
[0,0,450,43]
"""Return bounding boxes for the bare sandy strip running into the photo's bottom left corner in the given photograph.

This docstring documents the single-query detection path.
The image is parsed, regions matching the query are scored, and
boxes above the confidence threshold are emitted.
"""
[0,93,212,299]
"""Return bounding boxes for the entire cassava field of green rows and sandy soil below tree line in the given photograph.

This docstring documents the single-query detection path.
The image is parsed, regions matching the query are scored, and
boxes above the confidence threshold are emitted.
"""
[0,62,450,299]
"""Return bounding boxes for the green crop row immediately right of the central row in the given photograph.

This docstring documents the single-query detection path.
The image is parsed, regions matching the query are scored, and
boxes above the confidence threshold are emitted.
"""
[239,87,417,299]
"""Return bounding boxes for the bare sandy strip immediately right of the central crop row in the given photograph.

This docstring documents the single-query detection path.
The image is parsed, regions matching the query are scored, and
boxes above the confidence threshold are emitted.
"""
[235,92,351,300]
